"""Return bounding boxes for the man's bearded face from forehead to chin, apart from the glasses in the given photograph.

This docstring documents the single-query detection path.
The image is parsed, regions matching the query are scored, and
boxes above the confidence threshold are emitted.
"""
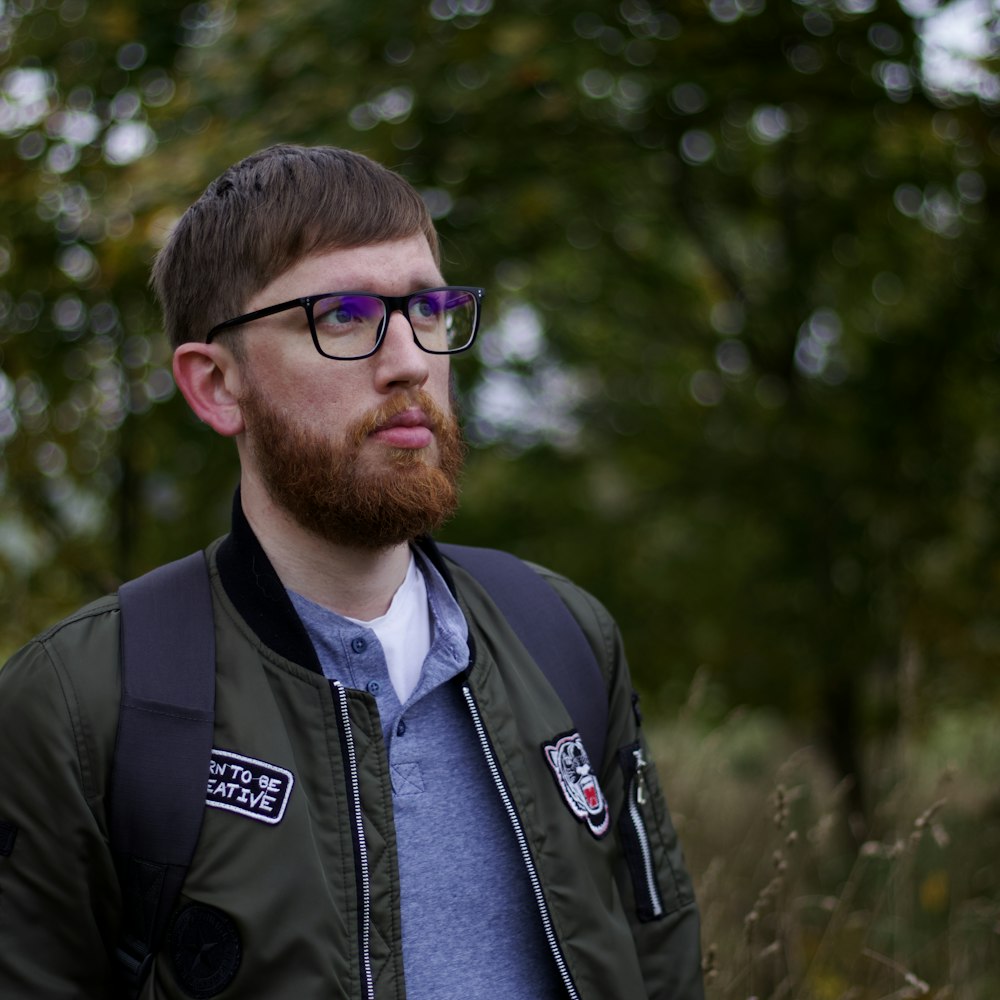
[236,236,463,549]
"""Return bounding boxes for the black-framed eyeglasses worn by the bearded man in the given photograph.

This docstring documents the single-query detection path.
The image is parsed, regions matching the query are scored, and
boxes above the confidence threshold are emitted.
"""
[205,285,485,361]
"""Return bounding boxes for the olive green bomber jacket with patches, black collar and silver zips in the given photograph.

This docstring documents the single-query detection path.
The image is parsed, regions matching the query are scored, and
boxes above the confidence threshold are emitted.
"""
[0,518,702,1000]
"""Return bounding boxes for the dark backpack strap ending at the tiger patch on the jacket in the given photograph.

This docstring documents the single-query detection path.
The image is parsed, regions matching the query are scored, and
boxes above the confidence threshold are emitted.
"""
[438,545,608,770]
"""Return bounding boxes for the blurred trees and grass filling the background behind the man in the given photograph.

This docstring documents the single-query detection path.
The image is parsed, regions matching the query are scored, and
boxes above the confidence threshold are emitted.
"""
[0,0,1000,1000]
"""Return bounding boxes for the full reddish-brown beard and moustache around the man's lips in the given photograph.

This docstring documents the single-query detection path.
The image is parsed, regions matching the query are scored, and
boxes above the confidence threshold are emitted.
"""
[240,382,465,550]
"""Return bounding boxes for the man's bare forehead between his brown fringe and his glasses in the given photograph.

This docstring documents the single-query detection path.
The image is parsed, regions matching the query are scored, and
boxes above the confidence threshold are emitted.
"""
[248,234,444,311]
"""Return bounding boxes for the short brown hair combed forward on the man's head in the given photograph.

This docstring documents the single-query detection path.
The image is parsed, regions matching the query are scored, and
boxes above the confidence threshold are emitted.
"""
[152,145,440,347]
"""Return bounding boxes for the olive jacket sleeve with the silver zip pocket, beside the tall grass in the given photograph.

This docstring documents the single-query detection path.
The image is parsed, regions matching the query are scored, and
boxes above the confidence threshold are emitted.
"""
[549,576,704,1000]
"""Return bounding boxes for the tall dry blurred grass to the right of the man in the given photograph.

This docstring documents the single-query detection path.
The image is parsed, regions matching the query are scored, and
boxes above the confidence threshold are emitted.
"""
[652,708,1000,1000]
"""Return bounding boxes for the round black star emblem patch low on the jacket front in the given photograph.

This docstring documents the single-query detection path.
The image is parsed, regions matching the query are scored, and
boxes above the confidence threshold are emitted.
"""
[169,903,240,1000]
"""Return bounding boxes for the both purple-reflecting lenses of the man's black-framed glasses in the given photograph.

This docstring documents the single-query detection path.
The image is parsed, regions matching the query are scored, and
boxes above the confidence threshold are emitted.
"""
[313,288,477,358]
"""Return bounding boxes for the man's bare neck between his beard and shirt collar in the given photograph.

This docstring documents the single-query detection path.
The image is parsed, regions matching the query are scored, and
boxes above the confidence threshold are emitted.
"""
[240,476,410,621]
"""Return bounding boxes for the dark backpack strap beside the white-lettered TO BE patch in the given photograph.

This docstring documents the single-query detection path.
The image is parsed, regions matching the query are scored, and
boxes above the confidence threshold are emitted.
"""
[110,552,215,997]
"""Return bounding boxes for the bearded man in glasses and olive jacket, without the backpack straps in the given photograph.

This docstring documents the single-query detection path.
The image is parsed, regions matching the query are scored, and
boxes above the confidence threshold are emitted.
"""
[0,146,701,1000]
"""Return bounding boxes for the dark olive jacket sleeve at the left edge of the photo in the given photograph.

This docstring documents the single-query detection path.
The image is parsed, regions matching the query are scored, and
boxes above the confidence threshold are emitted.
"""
[0,641,118,1000]
